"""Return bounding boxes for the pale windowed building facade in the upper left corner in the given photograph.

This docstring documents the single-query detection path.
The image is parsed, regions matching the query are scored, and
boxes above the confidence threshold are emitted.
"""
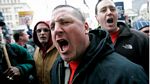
[0,0,30,28]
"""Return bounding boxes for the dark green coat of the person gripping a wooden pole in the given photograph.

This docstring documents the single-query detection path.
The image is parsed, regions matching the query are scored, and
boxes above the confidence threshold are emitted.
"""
[0,44,34,84]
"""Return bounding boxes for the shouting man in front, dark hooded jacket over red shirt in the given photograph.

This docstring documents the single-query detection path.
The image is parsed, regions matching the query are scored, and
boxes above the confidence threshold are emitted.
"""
[50,5,148,84]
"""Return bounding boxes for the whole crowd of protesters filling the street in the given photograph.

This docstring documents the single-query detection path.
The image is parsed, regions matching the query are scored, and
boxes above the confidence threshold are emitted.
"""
[0,0,149,84]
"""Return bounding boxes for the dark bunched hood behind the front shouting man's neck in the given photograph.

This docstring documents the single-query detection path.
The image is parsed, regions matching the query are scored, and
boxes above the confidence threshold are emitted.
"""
[77,30,114,71]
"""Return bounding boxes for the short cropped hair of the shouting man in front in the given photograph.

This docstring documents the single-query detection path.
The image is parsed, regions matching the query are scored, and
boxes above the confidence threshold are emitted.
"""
[53,5,85,22]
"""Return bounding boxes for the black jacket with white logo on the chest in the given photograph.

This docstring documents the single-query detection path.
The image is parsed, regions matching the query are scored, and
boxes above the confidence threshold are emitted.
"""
[115,22,149,75]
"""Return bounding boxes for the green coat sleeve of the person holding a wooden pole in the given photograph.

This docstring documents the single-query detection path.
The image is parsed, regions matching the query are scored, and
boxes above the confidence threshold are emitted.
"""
[10,45,34,78]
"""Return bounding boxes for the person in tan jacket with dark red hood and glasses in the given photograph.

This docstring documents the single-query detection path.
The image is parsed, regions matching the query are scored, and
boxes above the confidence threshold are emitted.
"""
[33,21,58,84]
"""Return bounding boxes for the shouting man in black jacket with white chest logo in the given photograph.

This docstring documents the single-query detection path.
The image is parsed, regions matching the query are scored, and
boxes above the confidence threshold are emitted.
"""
[95,0,149,75]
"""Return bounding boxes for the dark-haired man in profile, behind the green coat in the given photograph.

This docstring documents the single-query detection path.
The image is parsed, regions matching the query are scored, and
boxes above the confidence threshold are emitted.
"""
[13,30,34,56]
